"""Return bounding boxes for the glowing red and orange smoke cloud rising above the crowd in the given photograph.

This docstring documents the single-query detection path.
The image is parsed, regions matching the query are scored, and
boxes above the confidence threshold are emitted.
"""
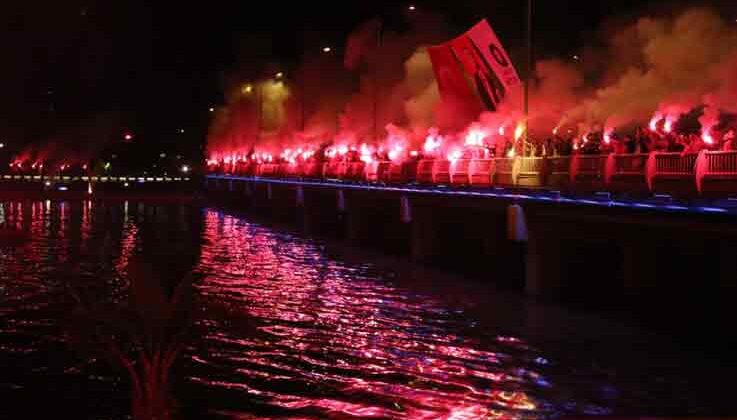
[210,8,737,164]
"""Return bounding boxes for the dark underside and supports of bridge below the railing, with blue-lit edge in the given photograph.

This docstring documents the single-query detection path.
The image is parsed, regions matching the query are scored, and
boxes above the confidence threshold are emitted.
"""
[205,171,737,303]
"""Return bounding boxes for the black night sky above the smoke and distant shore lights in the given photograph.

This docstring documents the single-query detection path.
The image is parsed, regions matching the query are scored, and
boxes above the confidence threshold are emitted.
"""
[0,0,737,156]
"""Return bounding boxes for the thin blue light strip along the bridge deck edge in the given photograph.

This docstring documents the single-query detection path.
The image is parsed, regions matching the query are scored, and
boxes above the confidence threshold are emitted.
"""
[207,175,737,215]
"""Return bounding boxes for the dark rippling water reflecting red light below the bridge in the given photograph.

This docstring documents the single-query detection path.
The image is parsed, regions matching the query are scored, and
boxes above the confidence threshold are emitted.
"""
[0,201,734,419]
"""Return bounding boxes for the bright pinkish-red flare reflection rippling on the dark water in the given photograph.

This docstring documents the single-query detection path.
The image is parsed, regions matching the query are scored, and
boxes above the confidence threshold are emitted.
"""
[192,211,545,419]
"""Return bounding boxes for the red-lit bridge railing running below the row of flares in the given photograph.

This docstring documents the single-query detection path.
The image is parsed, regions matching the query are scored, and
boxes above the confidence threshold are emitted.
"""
[220,151,737,194]
